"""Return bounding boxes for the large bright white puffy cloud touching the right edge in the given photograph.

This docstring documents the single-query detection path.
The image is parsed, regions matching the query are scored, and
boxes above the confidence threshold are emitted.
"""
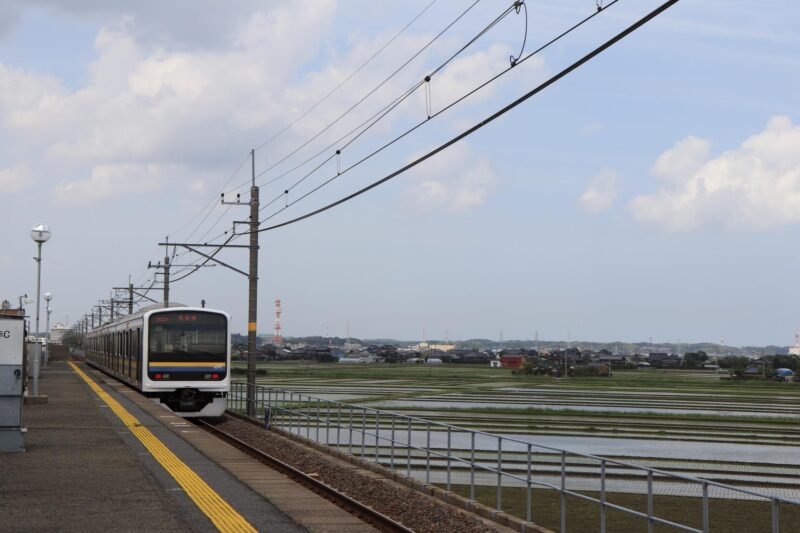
[630,116,800,230]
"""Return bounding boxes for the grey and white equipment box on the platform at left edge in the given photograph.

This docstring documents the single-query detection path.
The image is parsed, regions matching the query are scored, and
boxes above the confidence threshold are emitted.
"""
[0,315,25,453]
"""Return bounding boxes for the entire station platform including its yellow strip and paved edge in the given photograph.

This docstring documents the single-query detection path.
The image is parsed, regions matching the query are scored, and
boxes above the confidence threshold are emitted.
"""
[0,361,373,533]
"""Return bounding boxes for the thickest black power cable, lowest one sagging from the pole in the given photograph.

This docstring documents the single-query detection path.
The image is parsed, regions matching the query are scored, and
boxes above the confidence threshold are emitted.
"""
[253,0,680,232]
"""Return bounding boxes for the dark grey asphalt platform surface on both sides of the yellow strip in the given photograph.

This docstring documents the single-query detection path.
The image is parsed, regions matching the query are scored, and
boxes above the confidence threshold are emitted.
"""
[0,361,305,533]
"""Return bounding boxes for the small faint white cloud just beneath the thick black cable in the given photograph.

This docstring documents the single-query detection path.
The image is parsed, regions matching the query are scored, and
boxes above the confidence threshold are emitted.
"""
[406,142,498,212]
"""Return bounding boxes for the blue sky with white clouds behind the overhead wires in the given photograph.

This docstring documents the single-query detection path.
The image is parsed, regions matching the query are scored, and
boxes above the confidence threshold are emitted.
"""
[0,0,800,345]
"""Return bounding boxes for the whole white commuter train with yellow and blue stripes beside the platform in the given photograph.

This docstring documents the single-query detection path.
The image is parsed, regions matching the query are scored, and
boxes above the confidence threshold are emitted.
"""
[86,304,231,417]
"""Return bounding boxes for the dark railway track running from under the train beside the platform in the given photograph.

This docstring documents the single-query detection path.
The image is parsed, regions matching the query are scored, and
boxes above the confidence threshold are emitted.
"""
[193,419,414,533]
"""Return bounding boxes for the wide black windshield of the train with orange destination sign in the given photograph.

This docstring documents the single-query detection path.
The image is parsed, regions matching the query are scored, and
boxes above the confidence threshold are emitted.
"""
[148,311,228,361]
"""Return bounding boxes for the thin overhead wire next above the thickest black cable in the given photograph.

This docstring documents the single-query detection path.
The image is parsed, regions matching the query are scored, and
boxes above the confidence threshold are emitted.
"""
[253,0,619,223]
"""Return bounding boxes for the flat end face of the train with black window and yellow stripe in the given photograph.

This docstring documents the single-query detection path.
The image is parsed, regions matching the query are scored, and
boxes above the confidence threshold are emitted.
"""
[142,307,231,417]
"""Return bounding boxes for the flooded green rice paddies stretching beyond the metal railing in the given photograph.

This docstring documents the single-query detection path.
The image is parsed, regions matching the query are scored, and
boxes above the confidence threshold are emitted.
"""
[234,362,800,532]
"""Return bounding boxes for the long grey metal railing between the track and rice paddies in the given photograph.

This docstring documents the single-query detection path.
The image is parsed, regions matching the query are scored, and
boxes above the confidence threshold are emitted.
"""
[228,381,800,533]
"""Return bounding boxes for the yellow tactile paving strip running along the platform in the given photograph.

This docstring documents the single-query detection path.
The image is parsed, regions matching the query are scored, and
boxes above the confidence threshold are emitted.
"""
[69,362,256,533]
